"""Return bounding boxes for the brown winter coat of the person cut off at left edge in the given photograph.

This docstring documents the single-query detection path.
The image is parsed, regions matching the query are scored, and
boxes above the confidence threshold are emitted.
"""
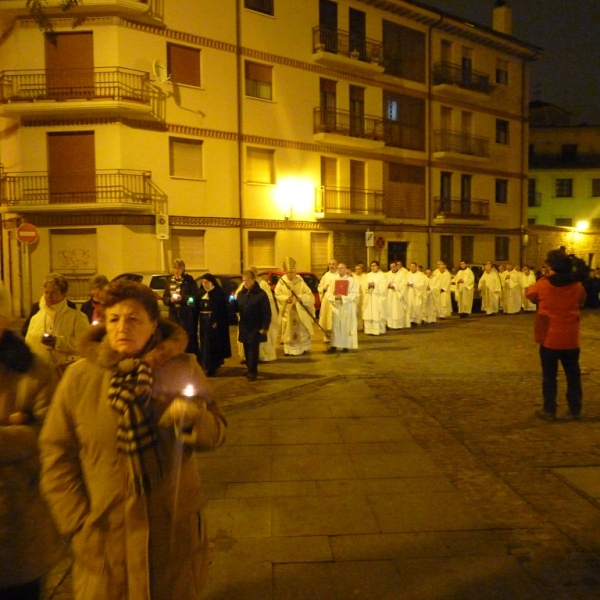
[0,331,63,589]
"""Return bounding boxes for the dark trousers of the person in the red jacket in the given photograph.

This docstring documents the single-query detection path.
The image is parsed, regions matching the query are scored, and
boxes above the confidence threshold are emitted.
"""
[540,346,583,415]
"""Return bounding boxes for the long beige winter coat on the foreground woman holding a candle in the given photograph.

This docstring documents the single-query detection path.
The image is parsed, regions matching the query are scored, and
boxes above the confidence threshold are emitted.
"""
[40,321,226,600]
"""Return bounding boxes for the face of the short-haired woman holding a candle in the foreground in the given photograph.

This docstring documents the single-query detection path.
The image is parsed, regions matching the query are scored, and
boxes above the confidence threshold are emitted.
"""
[105,298,157,357]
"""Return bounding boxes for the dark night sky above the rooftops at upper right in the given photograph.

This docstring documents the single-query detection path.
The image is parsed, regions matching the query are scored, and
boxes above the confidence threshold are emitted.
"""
[423,0,600,124]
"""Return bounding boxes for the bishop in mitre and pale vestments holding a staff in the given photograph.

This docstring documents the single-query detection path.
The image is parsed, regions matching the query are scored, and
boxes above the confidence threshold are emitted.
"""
[275,257,315,356]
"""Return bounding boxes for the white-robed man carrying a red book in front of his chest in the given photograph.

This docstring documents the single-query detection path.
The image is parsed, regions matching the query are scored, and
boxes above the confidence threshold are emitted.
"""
[325,263,359,353]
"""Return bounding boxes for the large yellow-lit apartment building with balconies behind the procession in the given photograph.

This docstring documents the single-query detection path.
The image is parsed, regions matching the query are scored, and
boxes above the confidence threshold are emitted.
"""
[0,0,539,312]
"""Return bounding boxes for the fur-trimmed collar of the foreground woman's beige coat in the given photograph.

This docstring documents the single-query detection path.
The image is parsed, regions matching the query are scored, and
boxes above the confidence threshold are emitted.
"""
[77,319,188,369]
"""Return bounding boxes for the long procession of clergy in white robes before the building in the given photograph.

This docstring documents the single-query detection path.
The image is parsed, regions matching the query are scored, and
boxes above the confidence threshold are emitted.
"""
[261,257,536,360]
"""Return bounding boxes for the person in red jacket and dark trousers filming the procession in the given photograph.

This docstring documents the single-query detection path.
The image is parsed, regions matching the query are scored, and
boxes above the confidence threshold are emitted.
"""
[525,250,585,421]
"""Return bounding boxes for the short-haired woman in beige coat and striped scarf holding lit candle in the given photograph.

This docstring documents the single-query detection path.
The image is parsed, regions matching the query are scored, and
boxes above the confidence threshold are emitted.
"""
[40,280,226,600]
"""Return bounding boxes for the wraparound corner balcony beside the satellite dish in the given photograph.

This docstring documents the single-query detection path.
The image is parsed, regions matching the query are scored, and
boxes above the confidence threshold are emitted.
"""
[0,68,166,121]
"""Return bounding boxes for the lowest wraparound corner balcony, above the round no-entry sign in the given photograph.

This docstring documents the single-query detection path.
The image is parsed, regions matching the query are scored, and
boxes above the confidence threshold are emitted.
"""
[0,169,167,213]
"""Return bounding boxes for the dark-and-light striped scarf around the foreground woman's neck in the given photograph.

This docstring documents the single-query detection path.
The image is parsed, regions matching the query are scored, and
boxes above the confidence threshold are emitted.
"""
[108,359,162,496]
